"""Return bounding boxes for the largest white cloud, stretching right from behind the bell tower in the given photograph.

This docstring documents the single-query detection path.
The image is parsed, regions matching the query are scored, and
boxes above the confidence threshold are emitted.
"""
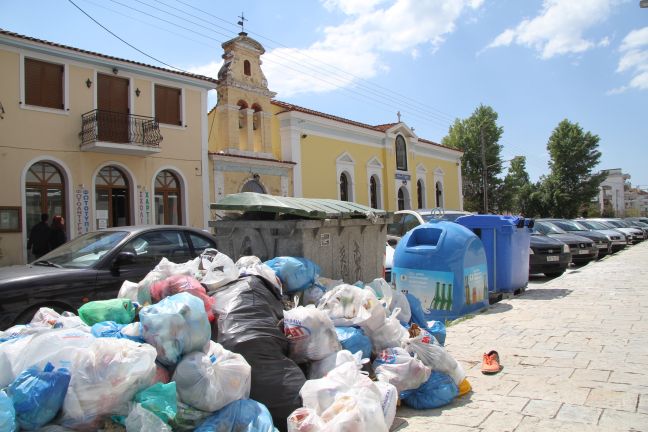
[263,0,484,97]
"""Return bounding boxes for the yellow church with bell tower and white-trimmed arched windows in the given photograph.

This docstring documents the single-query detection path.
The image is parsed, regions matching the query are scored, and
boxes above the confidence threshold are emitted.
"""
[208,32,463,211]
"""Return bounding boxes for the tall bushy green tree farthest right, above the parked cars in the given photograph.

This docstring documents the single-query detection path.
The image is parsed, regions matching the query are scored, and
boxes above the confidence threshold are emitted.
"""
[541,119,606,218]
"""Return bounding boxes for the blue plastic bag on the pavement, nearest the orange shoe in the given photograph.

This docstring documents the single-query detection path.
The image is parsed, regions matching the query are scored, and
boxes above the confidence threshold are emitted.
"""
[400,371,459,409]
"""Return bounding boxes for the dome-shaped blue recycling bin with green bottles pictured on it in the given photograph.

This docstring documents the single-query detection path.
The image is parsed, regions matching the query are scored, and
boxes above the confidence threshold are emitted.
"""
[392,220,489,321]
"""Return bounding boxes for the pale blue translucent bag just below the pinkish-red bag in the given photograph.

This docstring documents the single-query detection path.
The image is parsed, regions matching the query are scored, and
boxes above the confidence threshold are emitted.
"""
[139,293,211,366]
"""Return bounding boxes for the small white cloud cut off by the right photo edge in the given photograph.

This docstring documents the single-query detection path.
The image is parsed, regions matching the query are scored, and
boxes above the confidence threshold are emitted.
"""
[608,27,648,94]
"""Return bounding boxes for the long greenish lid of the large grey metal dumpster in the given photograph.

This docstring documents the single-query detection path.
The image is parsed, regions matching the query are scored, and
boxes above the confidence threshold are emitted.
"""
[210,192,387,219]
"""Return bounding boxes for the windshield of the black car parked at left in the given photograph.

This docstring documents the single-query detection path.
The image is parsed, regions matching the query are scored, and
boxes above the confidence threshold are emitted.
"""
[32,231,128,268]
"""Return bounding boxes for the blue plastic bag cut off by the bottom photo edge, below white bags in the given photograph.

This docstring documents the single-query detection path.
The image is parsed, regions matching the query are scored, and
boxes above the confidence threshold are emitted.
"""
[195,399,277,432]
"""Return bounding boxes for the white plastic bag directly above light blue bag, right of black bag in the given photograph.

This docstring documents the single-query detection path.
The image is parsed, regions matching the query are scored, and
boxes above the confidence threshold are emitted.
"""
[317,284,385,329]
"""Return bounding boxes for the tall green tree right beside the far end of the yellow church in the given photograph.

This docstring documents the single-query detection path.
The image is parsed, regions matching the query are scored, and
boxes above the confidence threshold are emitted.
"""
[442,105,503,213]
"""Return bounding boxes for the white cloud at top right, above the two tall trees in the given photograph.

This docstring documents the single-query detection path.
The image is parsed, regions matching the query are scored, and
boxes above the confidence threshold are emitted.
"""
[487,0,620,59]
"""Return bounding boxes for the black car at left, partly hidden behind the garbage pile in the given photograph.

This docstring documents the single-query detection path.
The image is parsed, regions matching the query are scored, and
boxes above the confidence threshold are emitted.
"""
[0,225,216,329]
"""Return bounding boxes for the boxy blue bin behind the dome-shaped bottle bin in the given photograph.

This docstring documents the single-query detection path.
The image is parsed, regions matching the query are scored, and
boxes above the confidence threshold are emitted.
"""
[456,215,531,293]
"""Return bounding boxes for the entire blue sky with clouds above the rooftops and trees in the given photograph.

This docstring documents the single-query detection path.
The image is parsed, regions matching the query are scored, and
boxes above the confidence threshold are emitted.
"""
[0,0,648,186]
